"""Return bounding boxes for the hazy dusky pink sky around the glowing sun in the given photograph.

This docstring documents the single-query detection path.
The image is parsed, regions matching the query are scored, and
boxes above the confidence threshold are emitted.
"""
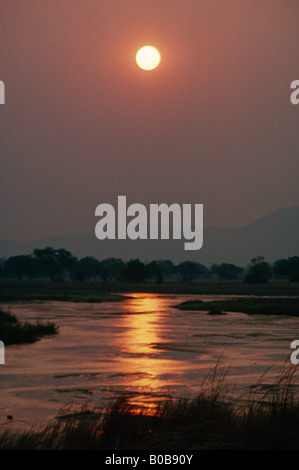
[0,0,299,240]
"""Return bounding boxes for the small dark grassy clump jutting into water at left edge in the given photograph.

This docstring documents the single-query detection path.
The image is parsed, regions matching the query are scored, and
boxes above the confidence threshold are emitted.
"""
[0,309,58,346]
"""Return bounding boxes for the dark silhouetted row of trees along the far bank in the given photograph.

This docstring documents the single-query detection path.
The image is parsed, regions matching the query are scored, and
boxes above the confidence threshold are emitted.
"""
[0,247,299,283]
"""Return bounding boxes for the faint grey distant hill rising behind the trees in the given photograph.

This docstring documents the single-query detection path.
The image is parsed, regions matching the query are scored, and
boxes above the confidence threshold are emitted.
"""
[0,207,299,266]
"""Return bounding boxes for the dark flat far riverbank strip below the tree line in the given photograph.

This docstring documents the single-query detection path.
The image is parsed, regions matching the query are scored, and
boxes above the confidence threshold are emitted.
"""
[0,280,299,302]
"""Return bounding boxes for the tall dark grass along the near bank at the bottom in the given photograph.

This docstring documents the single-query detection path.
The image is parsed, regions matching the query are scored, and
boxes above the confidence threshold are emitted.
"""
[0,365,299,450]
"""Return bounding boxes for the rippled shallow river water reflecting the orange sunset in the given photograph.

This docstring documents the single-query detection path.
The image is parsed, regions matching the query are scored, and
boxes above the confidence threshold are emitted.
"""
[0,294,299,426]
